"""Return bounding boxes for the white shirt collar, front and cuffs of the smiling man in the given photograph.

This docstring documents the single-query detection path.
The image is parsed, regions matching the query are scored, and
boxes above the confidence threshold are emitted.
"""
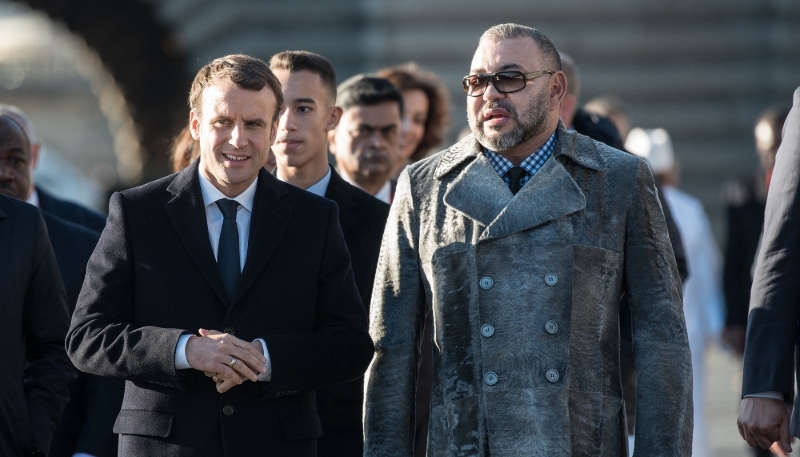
[175,171,272,381]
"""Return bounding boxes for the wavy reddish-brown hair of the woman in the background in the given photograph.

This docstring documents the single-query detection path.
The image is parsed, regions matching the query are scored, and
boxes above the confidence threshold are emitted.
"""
[378,62,450,162]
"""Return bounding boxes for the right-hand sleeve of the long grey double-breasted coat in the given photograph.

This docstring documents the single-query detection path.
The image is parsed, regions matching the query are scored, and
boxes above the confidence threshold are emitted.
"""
[625,161,693,456]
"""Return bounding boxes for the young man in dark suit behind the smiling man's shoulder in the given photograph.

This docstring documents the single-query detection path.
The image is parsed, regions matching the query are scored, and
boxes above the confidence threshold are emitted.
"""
[270,51,389,457]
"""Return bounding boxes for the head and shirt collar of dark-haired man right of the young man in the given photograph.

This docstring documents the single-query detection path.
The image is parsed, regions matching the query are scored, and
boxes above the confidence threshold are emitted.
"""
[328,75,403,203]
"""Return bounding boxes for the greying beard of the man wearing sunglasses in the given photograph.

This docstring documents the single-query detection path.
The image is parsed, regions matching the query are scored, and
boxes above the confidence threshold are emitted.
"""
[467,84,549,152]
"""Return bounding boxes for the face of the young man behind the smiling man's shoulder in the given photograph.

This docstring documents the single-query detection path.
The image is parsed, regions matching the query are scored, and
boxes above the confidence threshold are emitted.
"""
[272,69,341,176]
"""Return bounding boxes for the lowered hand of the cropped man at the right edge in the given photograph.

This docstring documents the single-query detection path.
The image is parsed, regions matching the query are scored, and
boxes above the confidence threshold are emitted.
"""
[737,397,792,454]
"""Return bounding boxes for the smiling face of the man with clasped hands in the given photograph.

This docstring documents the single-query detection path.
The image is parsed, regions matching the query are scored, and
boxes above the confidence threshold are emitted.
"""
[189,81,277,197]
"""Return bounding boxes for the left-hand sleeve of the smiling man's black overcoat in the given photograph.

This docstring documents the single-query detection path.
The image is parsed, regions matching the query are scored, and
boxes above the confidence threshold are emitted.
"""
[67,193,186,389]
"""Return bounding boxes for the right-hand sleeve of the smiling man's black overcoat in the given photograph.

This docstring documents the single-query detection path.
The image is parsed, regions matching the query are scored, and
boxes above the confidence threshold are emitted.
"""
[264,202,373,399]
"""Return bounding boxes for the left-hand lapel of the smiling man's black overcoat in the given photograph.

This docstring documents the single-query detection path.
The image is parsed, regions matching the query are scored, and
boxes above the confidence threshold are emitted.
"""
[164,160,230,306]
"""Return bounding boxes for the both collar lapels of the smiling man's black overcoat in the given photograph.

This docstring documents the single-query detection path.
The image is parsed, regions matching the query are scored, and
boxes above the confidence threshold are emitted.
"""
[165,160,291,309]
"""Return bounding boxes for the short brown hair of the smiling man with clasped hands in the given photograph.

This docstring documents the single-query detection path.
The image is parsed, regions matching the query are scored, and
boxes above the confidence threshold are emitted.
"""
[189,54,283,122]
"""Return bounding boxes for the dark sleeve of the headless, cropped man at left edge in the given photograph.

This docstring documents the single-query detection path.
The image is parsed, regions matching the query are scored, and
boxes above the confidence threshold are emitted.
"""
[23,210,76,453]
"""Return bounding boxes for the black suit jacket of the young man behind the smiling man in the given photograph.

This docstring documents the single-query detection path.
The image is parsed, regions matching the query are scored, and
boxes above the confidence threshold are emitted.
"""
[317,169,389,457]
